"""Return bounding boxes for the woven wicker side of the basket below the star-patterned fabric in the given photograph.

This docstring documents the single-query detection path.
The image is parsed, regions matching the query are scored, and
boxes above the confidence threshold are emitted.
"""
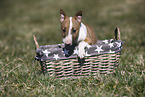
[40,52,120,78]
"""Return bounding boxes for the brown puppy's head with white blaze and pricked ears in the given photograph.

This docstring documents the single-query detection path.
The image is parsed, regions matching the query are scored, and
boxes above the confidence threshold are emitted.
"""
[60,9,82,45]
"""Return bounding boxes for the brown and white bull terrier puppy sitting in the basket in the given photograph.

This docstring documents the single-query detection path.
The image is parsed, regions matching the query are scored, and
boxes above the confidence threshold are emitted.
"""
[60,9,97,59]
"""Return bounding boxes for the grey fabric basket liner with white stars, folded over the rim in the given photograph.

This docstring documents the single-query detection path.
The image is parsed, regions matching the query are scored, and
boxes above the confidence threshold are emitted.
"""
[35,39,124,61]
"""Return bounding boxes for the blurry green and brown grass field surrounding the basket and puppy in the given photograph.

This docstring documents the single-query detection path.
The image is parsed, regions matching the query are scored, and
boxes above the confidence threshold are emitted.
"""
[0,0,145,97]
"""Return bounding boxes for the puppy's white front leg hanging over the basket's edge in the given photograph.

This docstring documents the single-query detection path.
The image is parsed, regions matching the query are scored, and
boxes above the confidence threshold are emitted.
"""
[78,41,89,59]
